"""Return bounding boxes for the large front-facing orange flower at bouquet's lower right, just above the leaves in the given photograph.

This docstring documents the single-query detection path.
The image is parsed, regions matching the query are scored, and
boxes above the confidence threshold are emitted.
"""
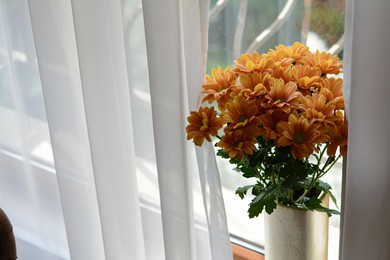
[276,114,327,159]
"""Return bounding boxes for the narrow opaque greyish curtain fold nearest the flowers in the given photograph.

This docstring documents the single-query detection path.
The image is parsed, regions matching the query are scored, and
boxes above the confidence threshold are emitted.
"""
[142,1,196,259]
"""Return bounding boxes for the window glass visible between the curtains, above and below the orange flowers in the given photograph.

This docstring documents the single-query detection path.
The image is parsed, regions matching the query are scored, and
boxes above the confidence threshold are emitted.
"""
[207,0,345,259]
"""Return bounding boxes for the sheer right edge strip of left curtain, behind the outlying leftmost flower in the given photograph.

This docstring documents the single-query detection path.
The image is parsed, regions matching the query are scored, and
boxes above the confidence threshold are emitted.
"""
[182,0,232,260]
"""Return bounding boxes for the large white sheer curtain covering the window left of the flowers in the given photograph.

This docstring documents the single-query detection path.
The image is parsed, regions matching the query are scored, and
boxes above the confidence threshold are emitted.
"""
[0,0,232,260]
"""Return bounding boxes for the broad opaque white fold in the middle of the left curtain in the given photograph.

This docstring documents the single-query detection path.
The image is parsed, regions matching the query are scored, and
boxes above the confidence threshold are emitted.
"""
[68,0,145,260]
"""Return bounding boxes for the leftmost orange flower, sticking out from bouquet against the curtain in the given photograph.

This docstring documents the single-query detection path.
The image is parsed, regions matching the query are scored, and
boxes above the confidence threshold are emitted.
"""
[186,107,223,146]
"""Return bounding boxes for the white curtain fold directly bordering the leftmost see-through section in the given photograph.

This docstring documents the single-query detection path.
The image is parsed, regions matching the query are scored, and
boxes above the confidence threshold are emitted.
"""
[29,0,104,259]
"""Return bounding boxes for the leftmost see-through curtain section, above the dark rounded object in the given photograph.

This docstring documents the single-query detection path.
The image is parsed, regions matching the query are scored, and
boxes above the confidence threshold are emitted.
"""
[0,1,69,260]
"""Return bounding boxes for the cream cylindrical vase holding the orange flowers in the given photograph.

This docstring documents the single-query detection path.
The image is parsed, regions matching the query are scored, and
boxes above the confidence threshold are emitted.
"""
[264,205,329,260]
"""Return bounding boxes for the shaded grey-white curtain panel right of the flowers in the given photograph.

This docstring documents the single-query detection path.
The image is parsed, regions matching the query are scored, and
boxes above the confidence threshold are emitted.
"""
[341,0,390,260]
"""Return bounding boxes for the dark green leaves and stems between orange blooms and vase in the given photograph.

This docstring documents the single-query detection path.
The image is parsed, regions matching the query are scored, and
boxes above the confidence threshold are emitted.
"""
[217,137,339,218]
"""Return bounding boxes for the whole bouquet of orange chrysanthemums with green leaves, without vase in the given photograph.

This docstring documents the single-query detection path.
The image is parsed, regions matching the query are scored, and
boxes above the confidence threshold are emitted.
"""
[186,42,348,218]
